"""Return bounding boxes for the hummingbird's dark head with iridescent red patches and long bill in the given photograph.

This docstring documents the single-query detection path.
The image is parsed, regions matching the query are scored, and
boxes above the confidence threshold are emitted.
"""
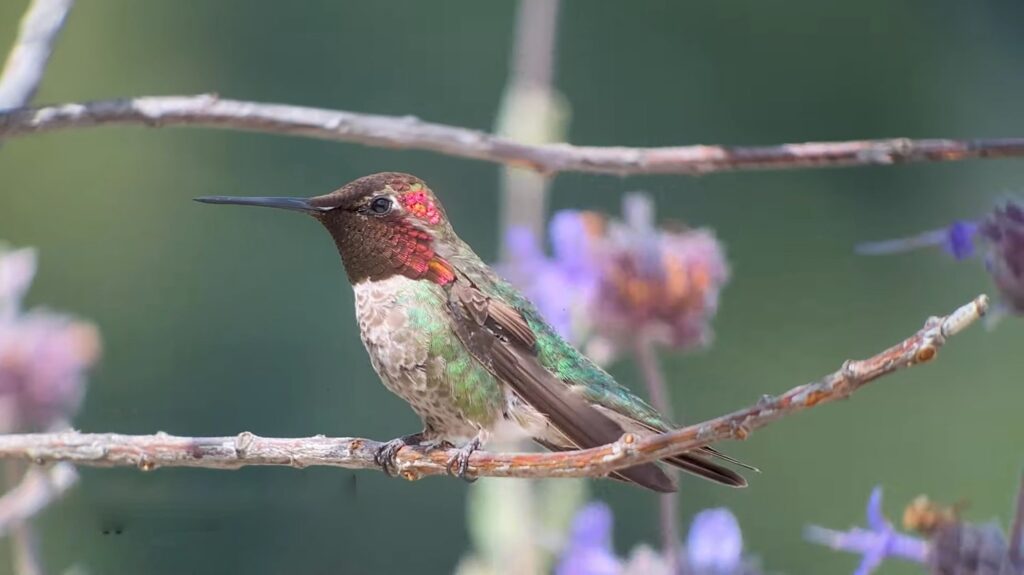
[196,172,455,284]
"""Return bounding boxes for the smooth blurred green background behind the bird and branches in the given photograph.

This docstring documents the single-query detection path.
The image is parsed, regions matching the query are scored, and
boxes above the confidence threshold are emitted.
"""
[0,0,1024,575]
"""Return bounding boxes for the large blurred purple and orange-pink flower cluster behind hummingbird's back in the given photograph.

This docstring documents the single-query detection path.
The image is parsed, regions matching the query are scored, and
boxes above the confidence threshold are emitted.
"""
[499,193,729,362]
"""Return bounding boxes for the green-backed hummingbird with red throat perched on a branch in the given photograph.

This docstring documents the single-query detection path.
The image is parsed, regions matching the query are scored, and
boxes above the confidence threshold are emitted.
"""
[196,172,754,492]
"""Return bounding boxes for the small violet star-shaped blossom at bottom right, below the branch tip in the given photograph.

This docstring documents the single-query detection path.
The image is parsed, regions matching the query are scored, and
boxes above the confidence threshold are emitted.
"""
[805,487,929,575]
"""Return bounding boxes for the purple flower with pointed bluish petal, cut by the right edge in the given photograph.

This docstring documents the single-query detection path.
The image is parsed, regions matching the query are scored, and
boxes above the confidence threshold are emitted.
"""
[856,201,1024,315]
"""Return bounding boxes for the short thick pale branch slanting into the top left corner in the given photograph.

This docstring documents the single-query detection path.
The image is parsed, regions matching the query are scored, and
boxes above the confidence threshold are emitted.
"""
[0,0,75,109]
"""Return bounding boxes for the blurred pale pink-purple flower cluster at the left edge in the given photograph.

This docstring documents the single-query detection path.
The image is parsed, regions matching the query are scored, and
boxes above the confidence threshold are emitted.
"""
[0,242,99,433]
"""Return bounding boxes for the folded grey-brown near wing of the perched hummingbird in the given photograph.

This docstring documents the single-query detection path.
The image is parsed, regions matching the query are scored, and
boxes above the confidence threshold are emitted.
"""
[450,278,676,493]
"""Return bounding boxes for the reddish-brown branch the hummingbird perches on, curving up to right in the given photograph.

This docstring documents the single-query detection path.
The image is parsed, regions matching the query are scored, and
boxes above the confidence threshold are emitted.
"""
[0,296,988,479]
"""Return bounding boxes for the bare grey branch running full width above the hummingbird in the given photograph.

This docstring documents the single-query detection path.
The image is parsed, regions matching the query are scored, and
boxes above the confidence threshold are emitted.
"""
[0,94,1024,175]
